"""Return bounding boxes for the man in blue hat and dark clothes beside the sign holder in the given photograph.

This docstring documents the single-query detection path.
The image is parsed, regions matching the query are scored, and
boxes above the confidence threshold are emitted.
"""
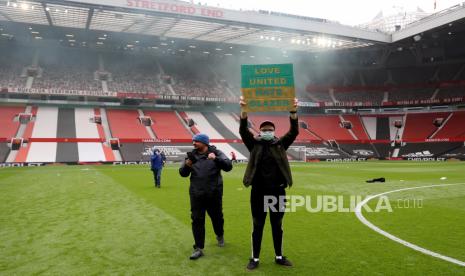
[179,134,232,260]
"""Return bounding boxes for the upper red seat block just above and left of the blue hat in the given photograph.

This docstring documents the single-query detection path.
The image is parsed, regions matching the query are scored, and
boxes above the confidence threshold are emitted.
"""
[144,110,192,139]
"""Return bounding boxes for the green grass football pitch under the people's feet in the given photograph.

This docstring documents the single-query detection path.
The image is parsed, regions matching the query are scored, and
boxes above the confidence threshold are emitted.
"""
[0,162,465,275]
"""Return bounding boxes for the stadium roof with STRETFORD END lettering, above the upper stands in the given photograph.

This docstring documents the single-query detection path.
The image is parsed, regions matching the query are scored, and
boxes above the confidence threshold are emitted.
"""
[0,0,465,51]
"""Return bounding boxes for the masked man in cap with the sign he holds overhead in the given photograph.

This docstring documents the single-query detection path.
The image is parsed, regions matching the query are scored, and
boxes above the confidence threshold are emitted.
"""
[239,64,299,270]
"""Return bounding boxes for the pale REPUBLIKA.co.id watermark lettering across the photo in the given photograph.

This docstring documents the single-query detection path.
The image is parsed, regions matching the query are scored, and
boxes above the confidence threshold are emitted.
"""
[263,195,423,213]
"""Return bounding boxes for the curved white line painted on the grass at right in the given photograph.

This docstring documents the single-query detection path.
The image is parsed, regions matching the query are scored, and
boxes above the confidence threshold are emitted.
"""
[355,183,465,267]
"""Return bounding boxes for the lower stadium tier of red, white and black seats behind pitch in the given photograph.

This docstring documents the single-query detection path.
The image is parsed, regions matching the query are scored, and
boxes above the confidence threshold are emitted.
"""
[0,106,465,162]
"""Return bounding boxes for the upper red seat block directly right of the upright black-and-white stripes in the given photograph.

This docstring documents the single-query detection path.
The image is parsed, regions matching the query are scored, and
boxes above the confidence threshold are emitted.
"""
[107,109,151,139]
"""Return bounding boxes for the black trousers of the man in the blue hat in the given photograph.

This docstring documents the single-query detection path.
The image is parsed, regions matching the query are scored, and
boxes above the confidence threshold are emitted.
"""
[190,193,224,249]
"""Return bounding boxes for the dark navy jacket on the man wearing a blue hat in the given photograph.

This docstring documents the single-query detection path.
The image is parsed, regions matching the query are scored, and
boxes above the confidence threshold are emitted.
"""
[179,146,232,195]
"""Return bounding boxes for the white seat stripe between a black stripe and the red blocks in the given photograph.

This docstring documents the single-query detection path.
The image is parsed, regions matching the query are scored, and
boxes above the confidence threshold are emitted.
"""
[74,108,106,162]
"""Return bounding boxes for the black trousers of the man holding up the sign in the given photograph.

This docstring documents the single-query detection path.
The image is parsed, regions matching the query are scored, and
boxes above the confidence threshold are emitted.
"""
[250,186,286,258]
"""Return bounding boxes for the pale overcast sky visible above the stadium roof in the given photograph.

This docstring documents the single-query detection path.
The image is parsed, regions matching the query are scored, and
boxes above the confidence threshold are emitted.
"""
[193,0,465,25]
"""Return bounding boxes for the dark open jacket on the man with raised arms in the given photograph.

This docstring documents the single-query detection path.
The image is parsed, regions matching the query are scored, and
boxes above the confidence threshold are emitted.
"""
[239,115,299,187]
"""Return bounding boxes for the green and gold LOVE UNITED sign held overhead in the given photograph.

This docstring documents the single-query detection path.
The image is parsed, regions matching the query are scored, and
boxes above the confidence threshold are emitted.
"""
[241,64,295,112]
